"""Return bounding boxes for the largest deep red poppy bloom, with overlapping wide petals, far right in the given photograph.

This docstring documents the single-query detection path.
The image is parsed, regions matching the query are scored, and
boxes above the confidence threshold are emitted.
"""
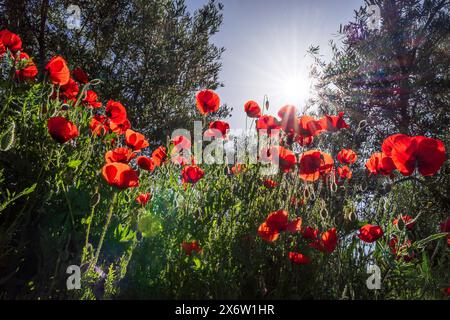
[382,134,447,176]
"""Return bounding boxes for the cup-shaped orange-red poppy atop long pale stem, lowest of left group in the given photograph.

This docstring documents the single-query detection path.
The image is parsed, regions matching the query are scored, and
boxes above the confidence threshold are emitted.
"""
[102,162,139,189]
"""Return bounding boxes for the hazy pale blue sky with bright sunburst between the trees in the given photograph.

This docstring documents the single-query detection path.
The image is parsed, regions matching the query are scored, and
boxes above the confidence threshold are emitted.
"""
[186,0,363,128]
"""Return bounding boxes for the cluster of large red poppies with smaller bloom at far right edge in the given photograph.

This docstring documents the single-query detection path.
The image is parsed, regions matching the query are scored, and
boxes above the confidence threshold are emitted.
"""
[366,134,447,176]
